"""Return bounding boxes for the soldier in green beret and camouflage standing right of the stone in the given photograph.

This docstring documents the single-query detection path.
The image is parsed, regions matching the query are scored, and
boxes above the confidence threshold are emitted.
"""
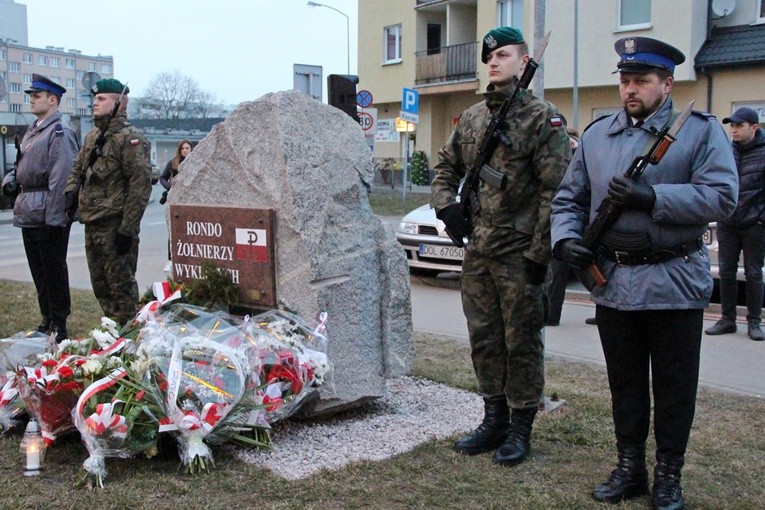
[431,27,571,466]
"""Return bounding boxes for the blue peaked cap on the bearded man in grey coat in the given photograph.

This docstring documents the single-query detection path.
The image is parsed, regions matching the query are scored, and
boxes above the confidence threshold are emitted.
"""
[614,37,685,73]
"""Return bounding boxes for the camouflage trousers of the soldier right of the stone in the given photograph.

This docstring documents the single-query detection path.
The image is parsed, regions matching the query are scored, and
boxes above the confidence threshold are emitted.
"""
[460,249,547,409]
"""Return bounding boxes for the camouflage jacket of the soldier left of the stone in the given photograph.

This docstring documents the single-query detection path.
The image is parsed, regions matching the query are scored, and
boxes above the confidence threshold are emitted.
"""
[66,111,151,237]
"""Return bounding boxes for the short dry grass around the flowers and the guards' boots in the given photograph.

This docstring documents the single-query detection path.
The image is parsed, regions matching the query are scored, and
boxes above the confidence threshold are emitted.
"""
[0,280,765,510]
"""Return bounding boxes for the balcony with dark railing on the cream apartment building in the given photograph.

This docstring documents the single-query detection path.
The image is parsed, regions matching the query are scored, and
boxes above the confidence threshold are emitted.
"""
[414,42,478,85]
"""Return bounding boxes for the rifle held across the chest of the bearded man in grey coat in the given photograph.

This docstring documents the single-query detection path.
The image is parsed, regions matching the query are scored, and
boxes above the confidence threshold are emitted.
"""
[582,97,695,287]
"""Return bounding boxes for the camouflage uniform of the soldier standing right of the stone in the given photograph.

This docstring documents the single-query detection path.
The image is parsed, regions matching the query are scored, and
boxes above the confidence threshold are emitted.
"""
[431,82,571,409]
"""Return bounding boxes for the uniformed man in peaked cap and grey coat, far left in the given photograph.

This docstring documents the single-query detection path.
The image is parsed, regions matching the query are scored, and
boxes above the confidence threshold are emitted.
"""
[3,74,78,342]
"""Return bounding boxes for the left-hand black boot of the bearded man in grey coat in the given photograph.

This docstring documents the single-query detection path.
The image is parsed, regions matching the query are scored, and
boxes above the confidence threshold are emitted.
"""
[592,444,648,503]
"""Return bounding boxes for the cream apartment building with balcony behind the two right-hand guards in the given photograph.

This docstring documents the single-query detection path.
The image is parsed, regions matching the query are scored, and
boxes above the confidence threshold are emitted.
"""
[358,0,765,164]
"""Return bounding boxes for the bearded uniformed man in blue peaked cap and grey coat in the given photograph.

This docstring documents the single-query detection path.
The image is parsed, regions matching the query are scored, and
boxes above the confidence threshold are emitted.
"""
[552,37,738,510]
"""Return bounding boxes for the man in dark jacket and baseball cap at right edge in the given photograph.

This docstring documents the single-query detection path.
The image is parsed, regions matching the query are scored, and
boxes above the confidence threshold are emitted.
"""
[706,108,765,341]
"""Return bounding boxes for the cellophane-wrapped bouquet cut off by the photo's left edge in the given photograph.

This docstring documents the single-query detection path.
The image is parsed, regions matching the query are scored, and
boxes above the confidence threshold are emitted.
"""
[0,331,48,435]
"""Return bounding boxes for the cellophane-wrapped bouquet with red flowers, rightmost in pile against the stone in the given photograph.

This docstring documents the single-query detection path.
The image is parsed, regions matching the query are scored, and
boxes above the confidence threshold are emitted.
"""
[242,310,332,423]
